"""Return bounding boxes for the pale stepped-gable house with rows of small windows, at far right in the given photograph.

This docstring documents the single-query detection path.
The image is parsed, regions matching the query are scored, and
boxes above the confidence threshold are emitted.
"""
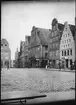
[60,22,75,68]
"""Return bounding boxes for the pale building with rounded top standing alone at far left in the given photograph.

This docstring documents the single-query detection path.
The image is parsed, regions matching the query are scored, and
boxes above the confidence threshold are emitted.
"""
[1,38,11,68]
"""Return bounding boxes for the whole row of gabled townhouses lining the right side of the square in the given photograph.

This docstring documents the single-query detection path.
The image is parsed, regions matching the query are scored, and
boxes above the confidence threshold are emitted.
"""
[16,18,76,68]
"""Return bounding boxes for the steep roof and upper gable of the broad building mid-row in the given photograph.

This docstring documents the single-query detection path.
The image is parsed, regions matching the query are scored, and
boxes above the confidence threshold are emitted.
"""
[29,27,51,48]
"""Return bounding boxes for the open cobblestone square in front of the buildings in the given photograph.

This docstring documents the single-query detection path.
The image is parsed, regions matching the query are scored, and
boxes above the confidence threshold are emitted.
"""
[1,68,75,93]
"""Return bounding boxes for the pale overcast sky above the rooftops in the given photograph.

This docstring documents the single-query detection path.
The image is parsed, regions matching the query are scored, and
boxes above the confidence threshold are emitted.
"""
[1,1,75,60]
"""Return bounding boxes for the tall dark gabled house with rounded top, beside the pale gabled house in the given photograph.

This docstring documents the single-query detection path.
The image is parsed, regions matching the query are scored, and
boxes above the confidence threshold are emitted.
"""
[49,18,64,68]
